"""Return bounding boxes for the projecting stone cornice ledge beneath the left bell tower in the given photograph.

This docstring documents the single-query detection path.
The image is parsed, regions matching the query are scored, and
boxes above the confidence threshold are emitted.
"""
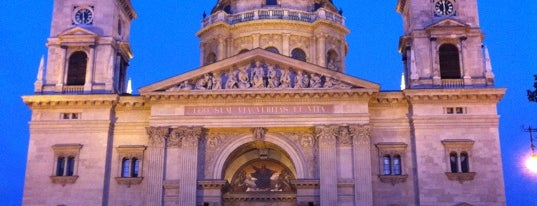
[22,94,118,108]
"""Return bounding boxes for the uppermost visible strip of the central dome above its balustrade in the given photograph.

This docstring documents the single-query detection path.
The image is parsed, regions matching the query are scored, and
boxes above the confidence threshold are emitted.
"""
[211,0,337,14]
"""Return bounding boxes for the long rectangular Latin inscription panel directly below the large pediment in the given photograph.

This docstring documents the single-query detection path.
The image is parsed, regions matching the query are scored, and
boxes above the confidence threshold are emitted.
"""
[185,105,334,116]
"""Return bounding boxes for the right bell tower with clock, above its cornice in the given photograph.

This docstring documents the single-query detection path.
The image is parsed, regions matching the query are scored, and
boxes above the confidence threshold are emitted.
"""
[397,0,494,89]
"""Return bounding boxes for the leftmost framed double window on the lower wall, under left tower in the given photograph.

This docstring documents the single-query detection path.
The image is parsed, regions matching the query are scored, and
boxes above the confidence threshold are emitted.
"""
[50,144,82,185]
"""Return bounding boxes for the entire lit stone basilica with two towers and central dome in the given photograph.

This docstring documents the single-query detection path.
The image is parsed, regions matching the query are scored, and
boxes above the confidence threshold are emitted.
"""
[23,0,505,206]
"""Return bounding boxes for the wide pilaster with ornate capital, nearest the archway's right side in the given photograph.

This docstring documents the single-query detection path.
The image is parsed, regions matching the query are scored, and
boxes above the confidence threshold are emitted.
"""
[315,126,338,205]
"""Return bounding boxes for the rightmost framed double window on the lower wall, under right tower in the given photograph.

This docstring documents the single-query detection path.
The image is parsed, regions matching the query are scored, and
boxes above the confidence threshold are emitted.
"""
[442,139,476,183]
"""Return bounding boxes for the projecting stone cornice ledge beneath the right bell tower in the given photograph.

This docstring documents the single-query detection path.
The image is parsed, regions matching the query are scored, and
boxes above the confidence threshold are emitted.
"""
[403,88,506,104]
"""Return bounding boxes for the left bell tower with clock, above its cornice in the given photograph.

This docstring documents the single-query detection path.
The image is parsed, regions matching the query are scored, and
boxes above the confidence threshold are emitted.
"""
[34,0,136,94]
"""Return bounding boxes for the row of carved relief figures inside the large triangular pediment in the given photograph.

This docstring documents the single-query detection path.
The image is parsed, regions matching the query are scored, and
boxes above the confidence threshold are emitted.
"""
[166,61,354,91]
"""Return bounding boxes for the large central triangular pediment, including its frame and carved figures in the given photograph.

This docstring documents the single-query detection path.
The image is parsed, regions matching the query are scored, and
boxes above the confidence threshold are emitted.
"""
[139,49,380,95]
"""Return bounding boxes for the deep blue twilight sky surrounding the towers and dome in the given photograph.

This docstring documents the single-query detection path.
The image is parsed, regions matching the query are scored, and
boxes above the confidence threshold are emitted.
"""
[0,0,537,206]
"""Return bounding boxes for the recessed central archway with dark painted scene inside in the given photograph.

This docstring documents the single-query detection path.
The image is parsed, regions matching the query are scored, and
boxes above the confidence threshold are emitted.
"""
[222,140,297,206]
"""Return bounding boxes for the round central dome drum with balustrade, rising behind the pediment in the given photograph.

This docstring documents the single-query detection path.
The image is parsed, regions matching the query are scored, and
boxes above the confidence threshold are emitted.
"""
[197,0,349,72]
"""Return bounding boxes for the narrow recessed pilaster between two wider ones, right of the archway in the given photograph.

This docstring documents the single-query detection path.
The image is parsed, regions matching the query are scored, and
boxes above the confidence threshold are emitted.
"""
[337,126,355,206]
